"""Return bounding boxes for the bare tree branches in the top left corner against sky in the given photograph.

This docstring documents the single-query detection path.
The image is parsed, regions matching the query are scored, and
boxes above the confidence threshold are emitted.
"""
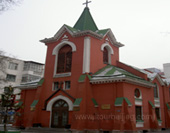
[0,0,21,13]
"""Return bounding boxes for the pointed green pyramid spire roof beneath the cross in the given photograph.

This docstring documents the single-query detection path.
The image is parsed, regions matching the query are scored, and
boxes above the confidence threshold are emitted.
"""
[73,7,98,31]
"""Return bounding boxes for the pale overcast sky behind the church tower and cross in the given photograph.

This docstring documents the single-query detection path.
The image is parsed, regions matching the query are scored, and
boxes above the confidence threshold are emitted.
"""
[0,0,170,69]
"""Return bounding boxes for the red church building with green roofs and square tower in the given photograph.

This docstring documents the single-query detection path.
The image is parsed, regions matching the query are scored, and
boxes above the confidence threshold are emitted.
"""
[16,3,170,132]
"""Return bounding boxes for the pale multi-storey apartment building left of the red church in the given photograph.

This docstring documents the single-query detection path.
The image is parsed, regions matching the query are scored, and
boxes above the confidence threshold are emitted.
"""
[0,56,44,89]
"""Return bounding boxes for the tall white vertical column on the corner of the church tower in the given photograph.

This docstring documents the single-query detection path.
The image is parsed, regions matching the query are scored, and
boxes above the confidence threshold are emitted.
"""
[83,37,91,73]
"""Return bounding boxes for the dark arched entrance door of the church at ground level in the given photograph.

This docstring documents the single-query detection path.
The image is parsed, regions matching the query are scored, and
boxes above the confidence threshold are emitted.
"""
[51,100,68,128]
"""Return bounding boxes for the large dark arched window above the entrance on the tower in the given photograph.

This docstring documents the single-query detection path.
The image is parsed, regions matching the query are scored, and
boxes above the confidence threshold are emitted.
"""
[57,45,72,73]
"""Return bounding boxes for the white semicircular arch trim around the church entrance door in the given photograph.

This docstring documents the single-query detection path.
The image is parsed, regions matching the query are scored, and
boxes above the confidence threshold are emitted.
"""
[46,95,73,111]
